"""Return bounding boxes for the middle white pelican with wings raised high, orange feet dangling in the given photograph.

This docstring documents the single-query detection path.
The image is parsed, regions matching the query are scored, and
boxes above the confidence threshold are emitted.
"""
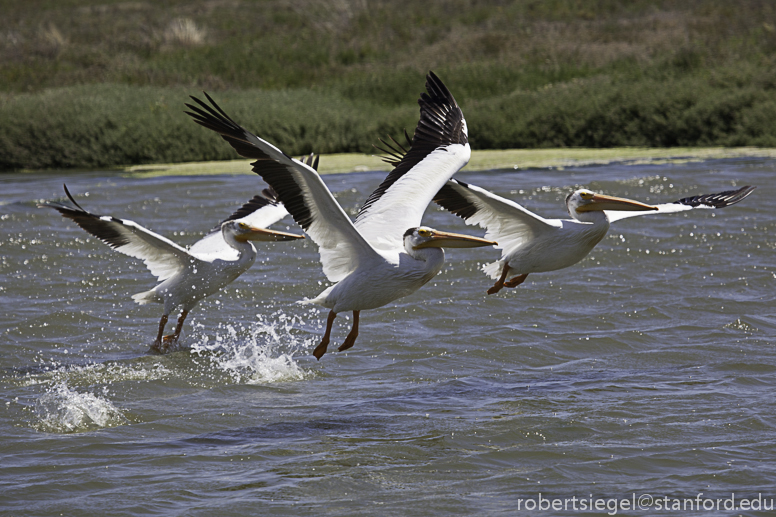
[187,73,495,359]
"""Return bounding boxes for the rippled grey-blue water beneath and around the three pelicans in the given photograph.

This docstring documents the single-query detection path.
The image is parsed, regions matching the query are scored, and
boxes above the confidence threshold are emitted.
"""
[0,159,776,516]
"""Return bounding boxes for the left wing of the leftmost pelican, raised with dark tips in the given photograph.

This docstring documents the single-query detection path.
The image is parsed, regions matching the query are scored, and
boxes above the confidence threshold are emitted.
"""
[38,185,193,281]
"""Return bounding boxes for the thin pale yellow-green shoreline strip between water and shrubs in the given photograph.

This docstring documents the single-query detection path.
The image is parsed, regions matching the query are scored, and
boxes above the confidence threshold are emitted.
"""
[119,147,776,177]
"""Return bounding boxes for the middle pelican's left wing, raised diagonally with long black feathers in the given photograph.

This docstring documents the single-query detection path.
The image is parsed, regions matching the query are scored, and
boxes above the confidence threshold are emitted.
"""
[186,94,380,282]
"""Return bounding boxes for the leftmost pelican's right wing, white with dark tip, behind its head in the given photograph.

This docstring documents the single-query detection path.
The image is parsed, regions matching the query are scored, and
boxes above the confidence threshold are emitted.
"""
[189,187,288,260]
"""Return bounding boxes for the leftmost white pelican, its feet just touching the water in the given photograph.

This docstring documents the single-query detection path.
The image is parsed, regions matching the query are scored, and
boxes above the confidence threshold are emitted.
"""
[38,181,304,352]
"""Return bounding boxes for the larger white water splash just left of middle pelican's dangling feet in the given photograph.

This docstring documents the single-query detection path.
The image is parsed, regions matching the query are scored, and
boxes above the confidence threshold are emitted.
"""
[191,312,311,384]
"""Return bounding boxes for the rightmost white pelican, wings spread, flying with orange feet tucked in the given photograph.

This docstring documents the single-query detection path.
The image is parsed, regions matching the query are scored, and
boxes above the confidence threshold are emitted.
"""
[434,180,755,294]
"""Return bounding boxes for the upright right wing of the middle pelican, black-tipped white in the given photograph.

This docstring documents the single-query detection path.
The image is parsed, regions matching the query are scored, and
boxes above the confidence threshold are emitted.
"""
[356,72,471,249]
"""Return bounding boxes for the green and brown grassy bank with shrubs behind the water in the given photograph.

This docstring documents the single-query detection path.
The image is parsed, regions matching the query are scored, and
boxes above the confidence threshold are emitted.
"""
[0,0,776,169]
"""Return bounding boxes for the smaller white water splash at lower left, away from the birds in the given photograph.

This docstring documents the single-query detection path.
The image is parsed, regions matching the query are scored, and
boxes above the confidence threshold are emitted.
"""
[34,382,127,433]
